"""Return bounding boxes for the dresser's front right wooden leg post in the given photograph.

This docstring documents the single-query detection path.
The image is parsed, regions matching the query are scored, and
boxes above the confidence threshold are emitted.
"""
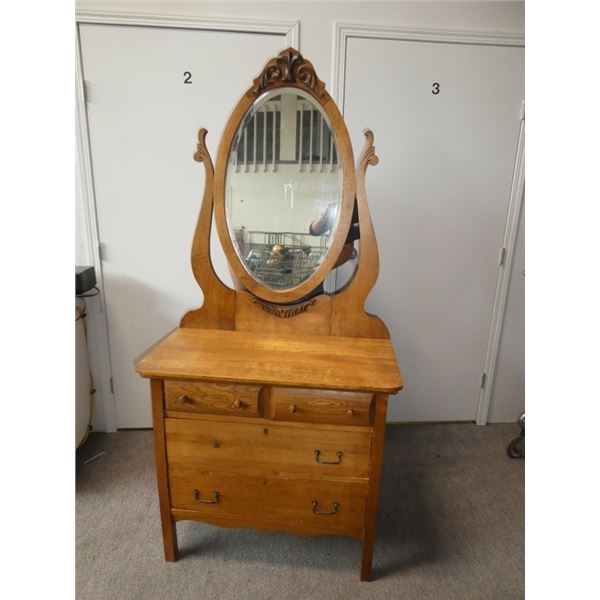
[360,394,387,581]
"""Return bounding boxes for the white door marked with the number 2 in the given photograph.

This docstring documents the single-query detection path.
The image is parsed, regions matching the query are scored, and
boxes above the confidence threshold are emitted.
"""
[80,24,287,428]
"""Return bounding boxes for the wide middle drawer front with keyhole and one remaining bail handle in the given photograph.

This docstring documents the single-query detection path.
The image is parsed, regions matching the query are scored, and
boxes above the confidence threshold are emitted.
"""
[165,419,371,479]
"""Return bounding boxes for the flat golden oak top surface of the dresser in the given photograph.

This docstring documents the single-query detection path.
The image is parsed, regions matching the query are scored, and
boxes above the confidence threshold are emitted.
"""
[136,328,403,394]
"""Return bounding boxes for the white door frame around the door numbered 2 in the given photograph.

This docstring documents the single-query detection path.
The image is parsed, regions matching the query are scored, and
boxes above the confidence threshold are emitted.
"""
[75,9,300,432]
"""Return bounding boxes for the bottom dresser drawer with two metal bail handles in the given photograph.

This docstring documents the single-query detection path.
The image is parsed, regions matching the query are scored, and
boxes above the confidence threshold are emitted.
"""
[169,469,367,537]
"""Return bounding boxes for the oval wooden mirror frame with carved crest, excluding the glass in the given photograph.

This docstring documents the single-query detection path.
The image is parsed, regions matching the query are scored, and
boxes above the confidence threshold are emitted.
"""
[214,48,356,303]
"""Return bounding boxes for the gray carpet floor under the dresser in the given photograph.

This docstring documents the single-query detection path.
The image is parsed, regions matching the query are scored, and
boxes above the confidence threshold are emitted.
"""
[76,424,524,600]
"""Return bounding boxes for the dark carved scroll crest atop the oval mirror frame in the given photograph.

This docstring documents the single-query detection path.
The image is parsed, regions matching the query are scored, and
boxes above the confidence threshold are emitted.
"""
[252,48,327,98]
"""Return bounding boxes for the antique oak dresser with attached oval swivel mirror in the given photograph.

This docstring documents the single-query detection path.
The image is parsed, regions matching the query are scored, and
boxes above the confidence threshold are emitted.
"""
[136,48,403,581]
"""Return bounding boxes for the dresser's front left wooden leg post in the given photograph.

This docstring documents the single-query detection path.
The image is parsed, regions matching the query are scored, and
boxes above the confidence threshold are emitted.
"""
[150,379,177,562]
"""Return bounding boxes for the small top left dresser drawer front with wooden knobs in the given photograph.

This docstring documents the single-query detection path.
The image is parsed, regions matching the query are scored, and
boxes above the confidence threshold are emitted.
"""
[165,380,261,417]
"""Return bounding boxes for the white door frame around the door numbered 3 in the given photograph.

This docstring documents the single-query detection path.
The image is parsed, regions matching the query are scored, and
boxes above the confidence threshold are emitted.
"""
[331,21,525,425]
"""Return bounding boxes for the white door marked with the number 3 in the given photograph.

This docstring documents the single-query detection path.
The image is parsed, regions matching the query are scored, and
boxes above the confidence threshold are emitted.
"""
[344,38,524,421]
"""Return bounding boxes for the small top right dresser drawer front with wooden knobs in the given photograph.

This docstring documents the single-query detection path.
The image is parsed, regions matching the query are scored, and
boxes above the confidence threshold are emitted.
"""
[270,387,373,425]
